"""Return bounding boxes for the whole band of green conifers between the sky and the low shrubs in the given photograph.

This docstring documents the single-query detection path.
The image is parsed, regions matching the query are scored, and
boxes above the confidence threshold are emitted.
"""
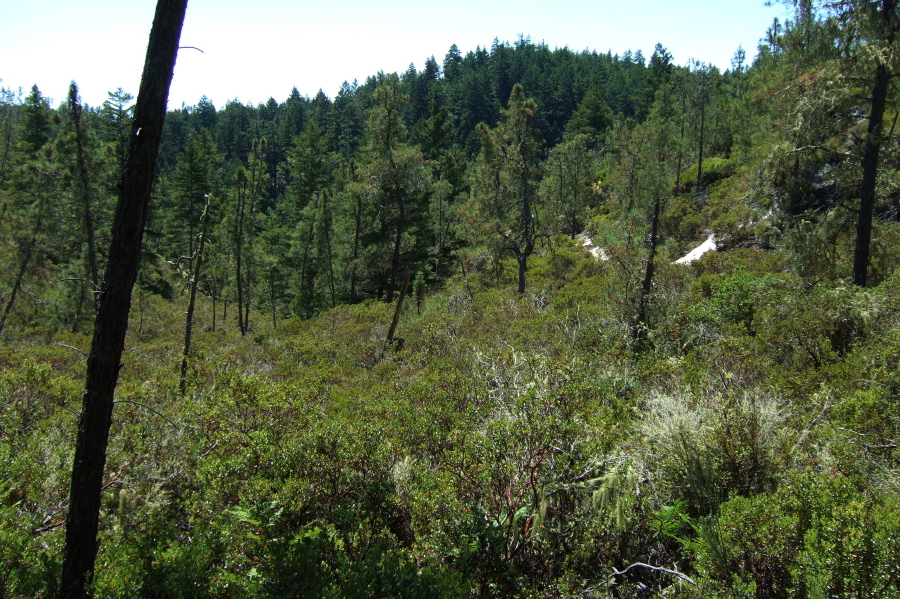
[0,9,894,334]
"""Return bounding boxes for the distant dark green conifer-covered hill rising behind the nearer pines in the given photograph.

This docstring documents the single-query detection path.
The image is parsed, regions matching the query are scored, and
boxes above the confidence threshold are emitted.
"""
[155,39,675,173]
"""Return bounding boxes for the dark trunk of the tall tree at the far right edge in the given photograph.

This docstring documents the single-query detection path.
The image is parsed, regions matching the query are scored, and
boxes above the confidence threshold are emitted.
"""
[853,0,897,287]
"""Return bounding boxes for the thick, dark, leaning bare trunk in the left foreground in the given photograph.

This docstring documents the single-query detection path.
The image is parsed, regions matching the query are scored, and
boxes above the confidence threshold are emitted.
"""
[60,0,187,599]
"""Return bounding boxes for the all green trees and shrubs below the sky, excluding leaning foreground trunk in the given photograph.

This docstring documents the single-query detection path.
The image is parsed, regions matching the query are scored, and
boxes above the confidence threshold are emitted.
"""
[0,0,900,599]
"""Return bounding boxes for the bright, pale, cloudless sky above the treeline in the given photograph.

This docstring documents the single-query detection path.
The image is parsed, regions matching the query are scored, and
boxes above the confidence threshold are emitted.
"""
[0,0,784,108]
